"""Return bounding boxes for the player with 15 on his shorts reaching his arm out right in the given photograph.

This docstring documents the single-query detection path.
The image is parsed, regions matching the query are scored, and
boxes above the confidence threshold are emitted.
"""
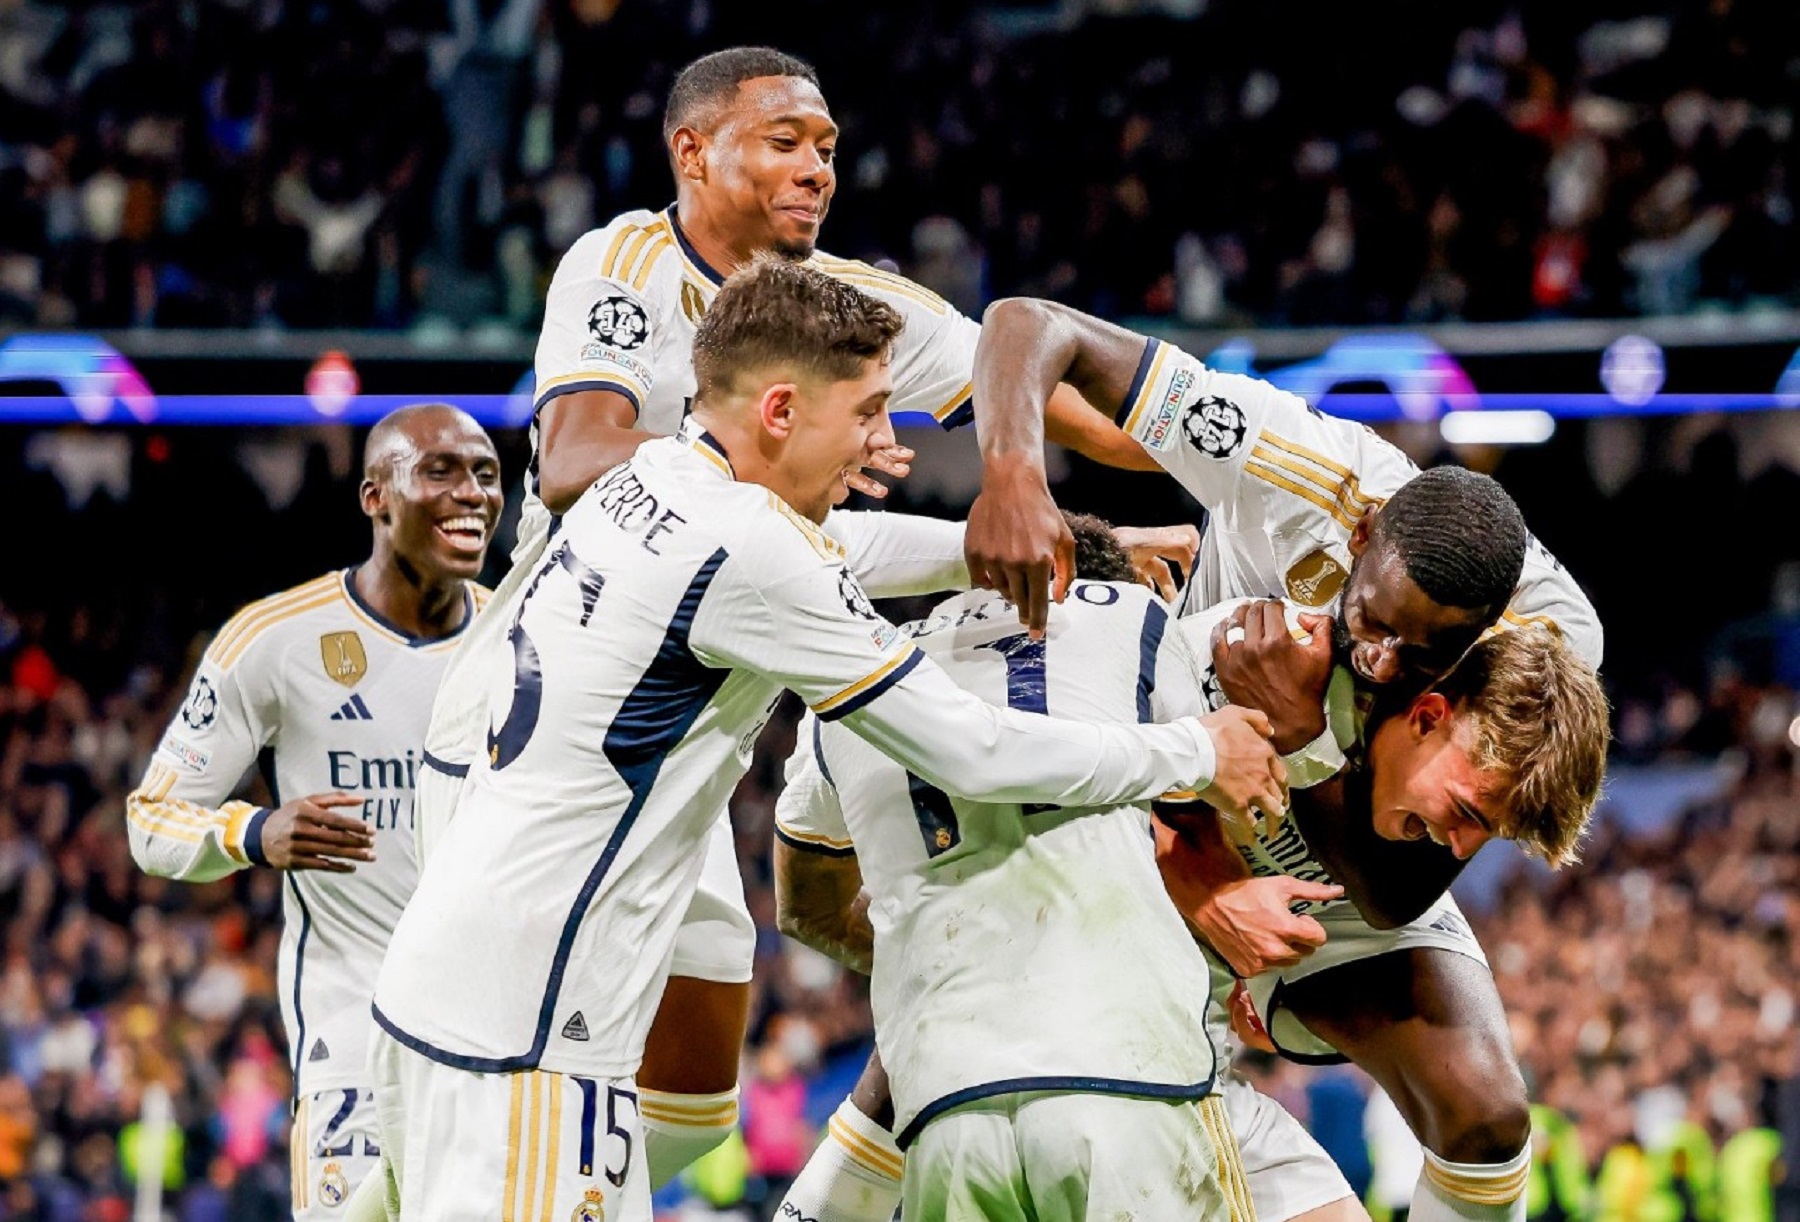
[373,259,1285,1222]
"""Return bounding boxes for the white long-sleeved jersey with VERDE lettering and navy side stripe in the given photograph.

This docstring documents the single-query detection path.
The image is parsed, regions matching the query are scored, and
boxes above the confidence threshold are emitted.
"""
[374,421,1213,1078]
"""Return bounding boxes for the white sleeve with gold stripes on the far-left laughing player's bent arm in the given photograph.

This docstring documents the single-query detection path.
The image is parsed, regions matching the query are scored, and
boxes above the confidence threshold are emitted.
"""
[124,651,270,882]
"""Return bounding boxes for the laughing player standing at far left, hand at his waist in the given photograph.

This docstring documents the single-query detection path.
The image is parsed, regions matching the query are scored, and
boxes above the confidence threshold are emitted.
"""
[126,403,500,1220]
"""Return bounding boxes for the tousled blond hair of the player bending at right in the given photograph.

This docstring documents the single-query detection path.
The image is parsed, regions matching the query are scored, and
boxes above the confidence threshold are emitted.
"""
[1436,624,1611,866]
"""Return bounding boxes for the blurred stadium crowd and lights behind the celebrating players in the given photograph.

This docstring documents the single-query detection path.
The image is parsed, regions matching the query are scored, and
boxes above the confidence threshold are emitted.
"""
[0,0,1800,1222]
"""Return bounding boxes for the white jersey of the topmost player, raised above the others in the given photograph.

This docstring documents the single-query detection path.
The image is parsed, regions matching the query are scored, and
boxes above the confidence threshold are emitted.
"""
[518,205,981,557]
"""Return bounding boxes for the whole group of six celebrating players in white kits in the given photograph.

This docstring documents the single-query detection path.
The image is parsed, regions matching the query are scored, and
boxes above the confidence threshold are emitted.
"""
[130,49,1607,1222]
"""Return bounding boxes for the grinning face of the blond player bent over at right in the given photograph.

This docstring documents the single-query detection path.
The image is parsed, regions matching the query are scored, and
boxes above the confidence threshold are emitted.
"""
[1368,693,1501,860]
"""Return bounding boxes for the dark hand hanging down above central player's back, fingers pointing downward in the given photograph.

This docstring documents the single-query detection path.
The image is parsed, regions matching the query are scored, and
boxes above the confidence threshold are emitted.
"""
[963,466,1075,639]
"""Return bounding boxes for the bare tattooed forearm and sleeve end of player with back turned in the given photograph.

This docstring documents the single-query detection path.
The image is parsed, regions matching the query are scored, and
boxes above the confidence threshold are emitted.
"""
[774,730,875,975]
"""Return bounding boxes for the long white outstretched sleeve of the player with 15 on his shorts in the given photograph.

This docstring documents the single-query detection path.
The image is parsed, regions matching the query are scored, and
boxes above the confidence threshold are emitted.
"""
[693,563,1215,806]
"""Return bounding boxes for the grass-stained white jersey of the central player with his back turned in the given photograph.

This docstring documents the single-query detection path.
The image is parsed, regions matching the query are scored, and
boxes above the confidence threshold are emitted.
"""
[776,581,1215,1146]
